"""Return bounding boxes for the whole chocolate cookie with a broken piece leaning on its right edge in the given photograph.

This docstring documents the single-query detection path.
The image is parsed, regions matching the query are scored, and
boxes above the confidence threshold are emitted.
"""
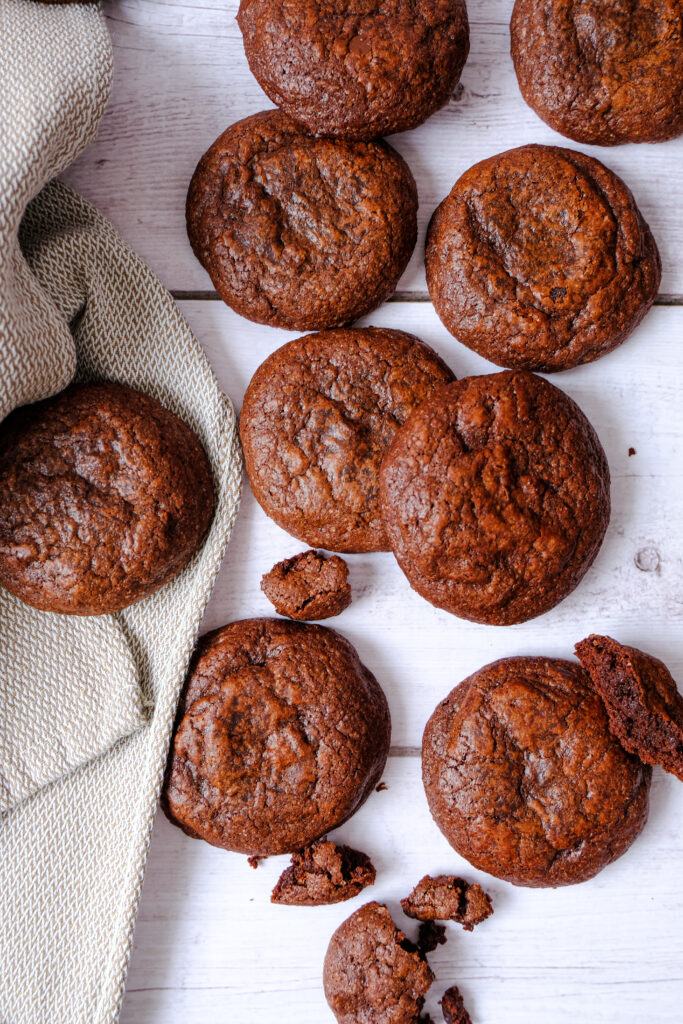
[422,657,651,887]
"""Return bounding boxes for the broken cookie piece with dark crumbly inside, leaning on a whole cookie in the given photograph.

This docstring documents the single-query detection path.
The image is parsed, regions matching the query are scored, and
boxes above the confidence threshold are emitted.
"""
[575,636,683,782]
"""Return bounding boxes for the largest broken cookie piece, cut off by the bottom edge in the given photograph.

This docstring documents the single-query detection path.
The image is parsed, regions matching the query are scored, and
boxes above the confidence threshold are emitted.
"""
[323,903,434,1024]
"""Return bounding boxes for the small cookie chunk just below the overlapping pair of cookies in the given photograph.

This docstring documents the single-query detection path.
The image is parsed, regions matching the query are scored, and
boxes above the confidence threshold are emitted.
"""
[261,551,351,620]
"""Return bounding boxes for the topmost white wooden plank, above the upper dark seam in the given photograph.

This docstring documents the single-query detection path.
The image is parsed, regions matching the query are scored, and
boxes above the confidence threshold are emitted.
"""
[60,0,683,295]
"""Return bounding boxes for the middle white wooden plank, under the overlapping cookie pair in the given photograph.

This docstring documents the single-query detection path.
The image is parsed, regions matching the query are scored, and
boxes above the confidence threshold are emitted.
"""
[174,302,683,746]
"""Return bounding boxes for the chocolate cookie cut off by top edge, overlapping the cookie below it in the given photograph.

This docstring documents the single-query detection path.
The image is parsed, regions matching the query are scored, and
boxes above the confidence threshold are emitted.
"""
[238,0,469,139]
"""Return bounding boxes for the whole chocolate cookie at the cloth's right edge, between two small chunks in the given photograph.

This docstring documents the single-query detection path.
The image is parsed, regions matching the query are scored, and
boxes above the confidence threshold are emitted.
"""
[165,618,391,857]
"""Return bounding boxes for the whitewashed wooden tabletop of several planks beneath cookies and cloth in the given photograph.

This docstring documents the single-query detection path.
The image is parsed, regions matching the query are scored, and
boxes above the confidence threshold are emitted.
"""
[66,0,683,1024]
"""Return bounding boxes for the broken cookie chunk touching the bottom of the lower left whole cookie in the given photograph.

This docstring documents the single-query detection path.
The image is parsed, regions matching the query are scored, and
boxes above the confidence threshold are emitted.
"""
[270,839,376,906]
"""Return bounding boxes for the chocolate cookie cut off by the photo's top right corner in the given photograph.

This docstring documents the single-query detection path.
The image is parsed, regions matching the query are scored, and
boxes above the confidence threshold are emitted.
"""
[510,0,683,145]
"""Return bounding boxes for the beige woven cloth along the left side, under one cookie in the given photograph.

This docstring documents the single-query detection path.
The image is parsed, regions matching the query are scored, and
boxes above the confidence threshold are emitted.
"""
[0,0,241,1024]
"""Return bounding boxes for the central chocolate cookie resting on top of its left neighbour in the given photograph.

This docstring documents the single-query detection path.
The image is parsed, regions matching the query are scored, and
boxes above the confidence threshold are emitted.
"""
[381,371,609,626]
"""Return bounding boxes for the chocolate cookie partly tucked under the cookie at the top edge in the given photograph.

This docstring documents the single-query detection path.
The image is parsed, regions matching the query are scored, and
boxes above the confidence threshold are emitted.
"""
[186,111,418,331]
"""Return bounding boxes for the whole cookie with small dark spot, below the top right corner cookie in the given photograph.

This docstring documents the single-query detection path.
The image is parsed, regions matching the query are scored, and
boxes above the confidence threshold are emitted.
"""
[426,145,661,373]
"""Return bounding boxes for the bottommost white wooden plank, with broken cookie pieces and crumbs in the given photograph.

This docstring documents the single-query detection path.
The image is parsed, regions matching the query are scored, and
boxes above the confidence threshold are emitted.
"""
[122,758,683,1024]
